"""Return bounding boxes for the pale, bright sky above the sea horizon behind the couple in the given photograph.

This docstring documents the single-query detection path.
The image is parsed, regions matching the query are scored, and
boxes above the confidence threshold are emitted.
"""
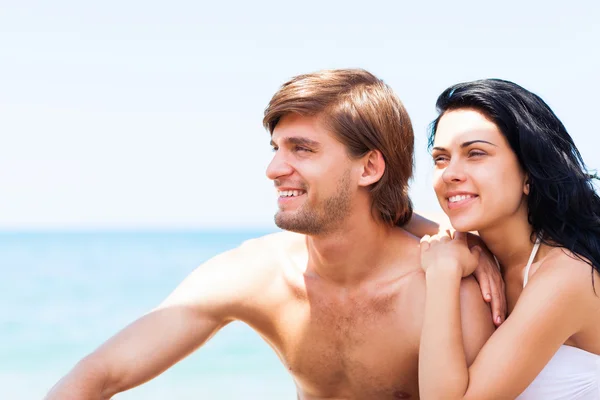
[0,0,600,231]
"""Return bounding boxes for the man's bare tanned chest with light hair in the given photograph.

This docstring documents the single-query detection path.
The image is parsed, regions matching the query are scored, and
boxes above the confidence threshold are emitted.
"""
[258,282,420,399]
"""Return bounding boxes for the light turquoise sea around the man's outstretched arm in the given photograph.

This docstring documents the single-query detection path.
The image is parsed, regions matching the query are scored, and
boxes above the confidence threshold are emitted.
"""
[0,232,295,400]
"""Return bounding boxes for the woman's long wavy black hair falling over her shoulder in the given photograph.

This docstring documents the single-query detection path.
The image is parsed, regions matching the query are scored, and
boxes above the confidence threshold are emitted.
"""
[429,79,600,290]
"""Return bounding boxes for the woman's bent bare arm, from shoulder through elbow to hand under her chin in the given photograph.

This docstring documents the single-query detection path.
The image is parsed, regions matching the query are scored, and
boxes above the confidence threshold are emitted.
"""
[419,239,591,400]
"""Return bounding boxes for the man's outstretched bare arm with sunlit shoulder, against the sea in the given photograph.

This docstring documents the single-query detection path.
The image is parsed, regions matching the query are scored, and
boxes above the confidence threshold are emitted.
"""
[46,241,269,400]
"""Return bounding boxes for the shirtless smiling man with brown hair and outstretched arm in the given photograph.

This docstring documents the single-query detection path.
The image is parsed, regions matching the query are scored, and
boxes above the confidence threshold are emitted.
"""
[48,70,502,399]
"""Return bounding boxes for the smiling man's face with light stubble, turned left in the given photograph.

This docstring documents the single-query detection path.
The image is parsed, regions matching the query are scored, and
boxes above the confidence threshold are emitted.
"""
[267,114,357,235]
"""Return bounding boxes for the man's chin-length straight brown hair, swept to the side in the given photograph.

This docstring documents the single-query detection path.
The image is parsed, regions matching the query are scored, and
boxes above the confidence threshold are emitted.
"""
[263,69,414,226]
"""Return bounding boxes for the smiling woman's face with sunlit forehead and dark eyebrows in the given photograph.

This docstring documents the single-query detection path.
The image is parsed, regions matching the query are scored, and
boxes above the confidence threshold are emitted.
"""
[432,109,529,232]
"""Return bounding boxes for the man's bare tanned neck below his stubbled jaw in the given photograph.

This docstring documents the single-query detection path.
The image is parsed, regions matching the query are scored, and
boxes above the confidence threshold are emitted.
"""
[306,215,398,286]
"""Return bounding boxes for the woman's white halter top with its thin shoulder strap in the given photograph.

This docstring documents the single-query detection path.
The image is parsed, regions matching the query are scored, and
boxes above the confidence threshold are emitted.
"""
[517,237,600,400]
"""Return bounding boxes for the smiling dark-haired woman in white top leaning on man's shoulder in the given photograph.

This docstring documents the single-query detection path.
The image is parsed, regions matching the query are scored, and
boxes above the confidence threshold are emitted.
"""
[419,80,600,400]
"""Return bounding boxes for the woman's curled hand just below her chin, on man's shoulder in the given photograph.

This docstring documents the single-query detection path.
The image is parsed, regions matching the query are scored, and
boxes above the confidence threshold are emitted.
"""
[421,232,481,277]
